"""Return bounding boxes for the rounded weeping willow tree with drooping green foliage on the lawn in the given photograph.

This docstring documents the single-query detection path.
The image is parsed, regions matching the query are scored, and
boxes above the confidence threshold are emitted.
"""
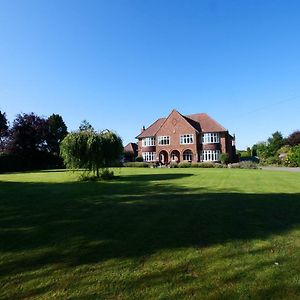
[60,130,123,178]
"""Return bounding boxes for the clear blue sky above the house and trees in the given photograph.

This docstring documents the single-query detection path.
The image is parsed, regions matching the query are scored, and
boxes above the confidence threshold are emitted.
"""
[0,0,300,149]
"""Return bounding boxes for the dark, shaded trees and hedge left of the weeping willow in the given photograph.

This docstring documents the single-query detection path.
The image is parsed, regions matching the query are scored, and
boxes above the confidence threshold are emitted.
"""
[0,111,68,172]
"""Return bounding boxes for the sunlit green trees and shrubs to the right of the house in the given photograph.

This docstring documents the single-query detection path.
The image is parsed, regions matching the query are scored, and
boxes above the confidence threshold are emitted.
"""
[248,130,300,167]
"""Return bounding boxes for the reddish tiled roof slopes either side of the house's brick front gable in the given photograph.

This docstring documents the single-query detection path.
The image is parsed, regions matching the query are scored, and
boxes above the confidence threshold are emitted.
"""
[136,112,227,139]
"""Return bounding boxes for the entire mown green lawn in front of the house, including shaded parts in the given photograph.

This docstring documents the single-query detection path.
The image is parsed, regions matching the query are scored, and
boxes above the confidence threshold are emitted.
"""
[0,168,300,299]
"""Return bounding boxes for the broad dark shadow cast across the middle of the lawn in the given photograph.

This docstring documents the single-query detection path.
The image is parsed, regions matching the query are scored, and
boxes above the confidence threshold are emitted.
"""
[0,174,300,275]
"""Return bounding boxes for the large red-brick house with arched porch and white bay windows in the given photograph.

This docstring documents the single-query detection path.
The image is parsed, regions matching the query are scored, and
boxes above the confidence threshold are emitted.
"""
[136,109,235,164]
